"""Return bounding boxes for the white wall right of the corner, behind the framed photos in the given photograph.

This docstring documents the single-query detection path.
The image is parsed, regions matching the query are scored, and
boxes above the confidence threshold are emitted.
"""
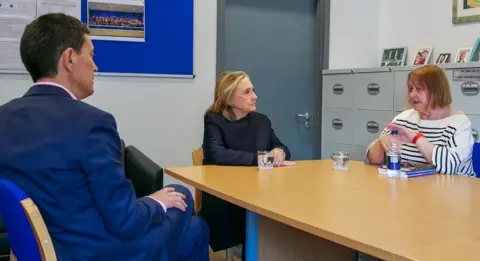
[379,0,480,64]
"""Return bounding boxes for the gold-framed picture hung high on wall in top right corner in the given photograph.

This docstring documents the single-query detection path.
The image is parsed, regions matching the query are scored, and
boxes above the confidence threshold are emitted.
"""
[452,0,480,24]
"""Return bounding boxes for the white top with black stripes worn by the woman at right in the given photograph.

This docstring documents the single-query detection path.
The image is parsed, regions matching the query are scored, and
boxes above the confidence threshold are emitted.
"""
[367,109,475,177]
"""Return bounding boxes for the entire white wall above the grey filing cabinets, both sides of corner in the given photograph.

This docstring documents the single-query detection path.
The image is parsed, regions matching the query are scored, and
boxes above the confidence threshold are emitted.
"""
[330,0,480,69]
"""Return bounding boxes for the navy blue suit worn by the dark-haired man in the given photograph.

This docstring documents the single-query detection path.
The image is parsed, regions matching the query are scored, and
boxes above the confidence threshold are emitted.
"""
[0,85,166,260]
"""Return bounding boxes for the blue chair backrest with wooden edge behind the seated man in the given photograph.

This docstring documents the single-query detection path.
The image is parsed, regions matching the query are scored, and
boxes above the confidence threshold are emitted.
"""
[0,178,57,261]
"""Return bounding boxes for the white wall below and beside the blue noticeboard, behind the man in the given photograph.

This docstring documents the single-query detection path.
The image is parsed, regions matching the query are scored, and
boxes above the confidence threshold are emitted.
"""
[0,0,217,191]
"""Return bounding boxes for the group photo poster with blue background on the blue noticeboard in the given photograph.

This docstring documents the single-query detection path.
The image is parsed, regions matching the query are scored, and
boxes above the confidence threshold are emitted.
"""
[87,0,145,42]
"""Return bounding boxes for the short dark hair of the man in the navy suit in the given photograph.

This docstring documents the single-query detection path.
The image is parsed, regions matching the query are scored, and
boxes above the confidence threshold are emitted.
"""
[20,13,90,82]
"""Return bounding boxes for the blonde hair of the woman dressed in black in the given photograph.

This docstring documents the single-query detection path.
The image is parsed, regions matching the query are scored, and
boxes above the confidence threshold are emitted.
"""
[205,71,250,121]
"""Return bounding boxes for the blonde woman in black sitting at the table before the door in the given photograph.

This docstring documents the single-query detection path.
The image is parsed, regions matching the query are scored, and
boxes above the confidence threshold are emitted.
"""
[200,71,290,256]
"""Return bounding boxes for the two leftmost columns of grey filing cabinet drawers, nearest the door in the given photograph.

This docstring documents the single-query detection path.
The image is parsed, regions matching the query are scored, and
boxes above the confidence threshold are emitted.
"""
[322,67,394,160]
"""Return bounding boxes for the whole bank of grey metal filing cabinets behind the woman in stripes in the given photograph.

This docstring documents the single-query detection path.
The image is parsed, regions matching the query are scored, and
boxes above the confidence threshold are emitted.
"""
[322,63,480,160]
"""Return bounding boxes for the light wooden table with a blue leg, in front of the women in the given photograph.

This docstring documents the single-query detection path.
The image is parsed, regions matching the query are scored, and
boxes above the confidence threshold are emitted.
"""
[165,160,480,261]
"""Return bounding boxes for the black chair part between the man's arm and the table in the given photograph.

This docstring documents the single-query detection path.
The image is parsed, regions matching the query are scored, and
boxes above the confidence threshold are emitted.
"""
[125,145,163,198]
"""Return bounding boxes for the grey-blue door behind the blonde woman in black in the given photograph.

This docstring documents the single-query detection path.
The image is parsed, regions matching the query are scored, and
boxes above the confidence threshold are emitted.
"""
[217,0,321,160]
